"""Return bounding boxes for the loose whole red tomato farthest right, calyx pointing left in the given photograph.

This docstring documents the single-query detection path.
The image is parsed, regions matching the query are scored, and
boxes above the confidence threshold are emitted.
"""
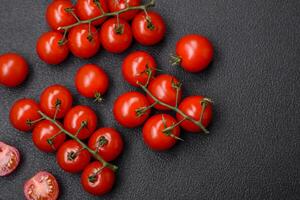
[176,34,214,73]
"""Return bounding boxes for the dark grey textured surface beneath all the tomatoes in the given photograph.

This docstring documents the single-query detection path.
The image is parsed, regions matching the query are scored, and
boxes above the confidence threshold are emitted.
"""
[0,0,300,200]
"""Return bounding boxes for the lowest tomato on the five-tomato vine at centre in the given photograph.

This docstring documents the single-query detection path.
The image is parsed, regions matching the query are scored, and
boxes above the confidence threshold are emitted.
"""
[143,114,180,151]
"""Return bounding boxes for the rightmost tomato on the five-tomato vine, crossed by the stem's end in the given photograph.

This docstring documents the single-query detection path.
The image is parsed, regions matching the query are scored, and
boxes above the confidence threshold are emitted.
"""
[176,96,213,133]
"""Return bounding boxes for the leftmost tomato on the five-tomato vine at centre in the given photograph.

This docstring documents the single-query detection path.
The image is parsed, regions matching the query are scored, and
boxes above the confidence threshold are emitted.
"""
[113,92,150,128]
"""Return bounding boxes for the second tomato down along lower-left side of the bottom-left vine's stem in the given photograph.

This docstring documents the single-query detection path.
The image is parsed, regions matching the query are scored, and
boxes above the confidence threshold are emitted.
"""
[32,120,66,153]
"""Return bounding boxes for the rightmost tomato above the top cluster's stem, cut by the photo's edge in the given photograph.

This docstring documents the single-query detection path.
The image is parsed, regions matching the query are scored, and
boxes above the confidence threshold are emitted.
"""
[108,0,141,20]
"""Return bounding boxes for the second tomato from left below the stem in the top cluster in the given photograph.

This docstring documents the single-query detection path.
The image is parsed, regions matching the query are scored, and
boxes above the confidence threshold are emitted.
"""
[68,24,100,58]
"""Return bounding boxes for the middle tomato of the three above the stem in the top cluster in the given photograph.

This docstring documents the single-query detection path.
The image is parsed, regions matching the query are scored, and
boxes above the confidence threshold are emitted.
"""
[75,0,108,26]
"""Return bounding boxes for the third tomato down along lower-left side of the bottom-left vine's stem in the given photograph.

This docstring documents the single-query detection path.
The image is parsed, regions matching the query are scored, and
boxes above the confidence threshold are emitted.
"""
[56,140,91,173]
